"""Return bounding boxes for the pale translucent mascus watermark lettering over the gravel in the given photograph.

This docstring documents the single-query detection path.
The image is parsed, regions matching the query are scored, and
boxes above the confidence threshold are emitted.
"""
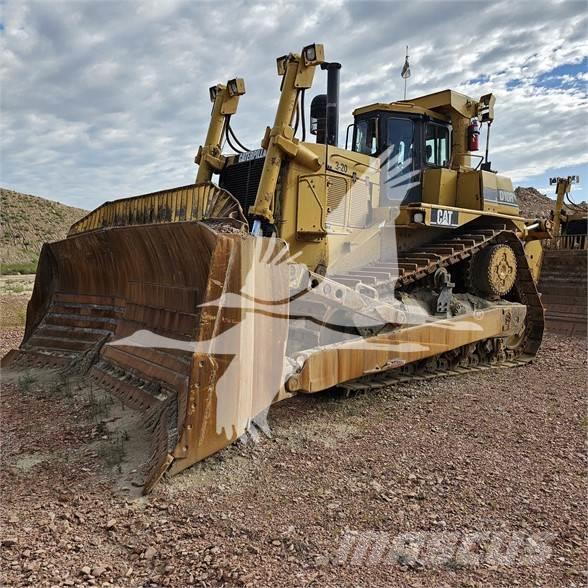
[337,531,556,568]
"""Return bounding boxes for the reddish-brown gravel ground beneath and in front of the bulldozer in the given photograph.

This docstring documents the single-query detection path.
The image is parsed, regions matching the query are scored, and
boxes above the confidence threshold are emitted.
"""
[0,330,588,587]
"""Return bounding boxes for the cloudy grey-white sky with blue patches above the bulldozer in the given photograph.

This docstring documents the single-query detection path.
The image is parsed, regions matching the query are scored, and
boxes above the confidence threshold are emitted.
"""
[0,0,588,209]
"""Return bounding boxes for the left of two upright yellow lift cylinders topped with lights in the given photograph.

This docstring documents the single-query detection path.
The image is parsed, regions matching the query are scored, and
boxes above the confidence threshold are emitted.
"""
[194,78,245,183]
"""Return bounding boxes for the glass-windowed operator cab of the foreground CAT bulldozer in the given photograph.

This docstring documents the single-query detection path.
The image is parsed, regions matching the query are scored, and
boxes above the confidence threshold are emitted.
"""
[352,102,451,206]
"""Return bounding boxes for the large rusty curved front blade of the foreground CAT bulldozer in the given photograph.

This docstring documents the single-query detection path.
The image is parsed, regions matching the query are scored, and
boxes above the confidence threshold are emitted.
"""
[3,191,288,491]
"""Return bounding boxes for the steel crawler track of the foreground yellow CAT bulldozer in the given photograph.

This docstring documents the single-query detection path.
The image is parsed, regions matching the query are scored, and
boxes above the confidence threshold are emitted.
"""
[292,225,544,390]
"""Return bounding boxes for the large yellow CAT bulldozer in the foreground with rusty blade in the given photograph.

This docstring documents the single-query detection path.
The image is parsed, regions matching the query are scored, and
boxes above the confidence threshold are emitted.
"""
[3,43,549,492]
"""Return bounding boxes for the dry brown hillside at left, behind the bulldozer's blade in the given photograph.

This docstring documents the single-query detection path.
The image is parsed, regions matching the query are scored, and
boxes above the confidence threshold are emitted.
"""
[0,188,87,273]
